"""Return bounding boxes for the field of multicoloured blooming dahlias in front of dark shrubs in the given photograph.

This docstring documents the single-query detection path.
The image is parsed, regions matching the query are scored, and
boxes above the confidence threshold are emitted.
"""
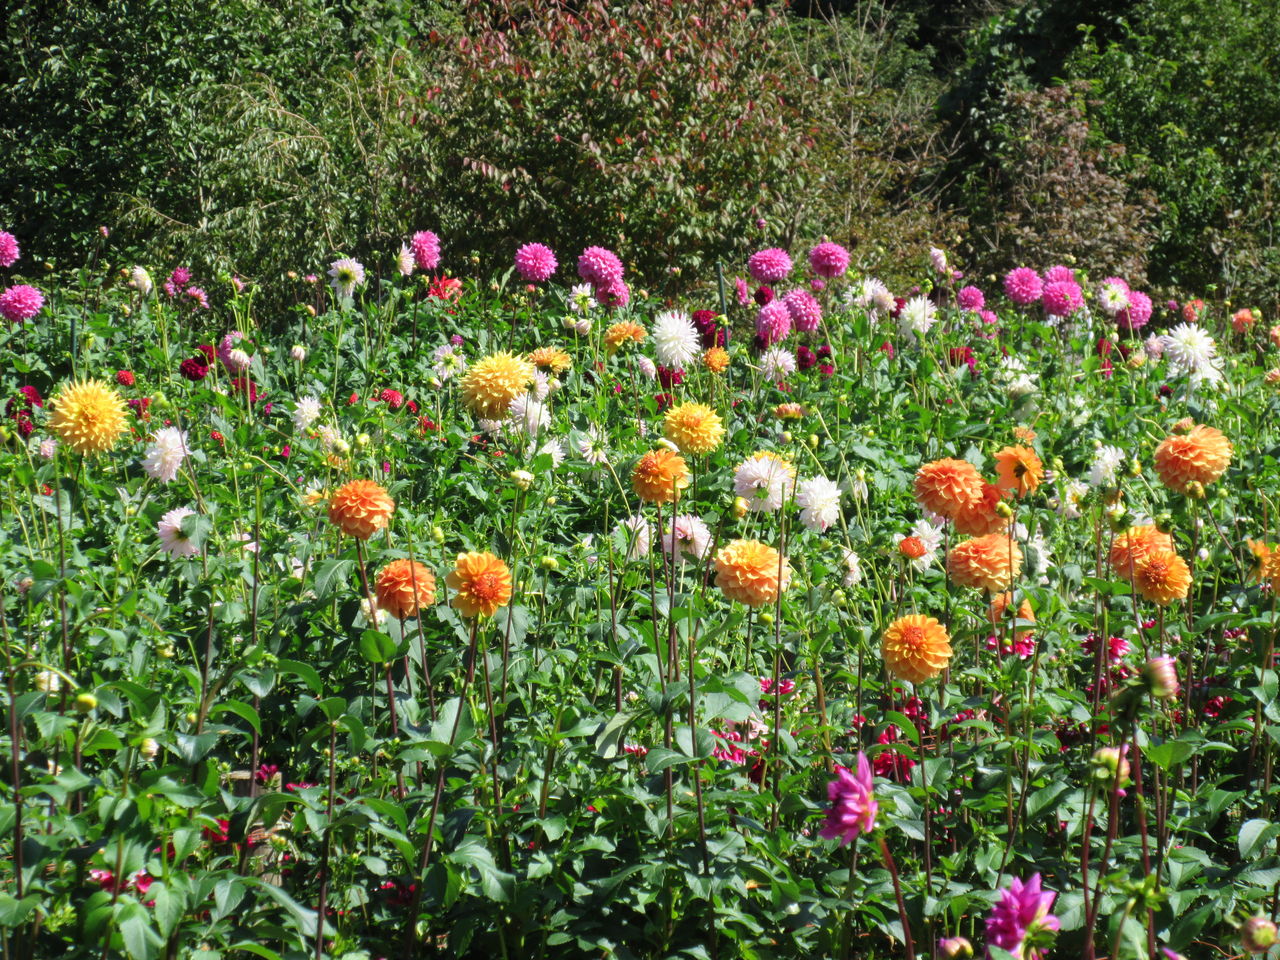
[0,230,1280,960]
